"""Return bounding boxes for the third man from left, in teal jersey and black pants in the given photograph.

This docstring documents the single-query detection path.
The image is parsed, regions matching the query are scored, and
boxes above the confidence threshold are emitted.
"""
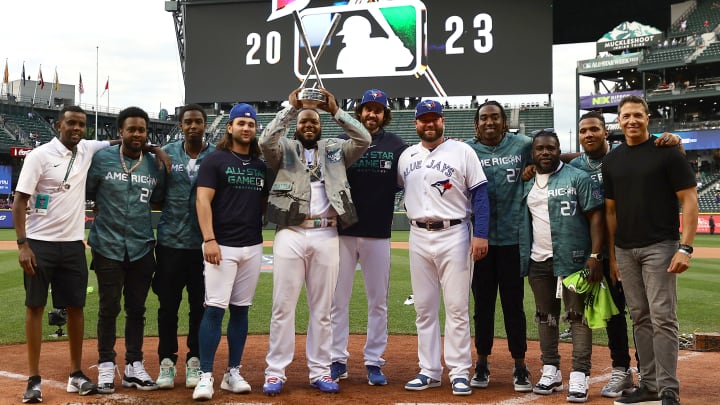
[152,104,215,389]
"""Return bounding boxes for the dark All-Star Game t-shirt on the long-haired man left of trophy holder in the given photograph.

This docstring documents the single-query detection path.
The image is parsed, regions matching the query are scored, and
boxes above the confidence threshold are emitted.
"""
[197,150,269,247]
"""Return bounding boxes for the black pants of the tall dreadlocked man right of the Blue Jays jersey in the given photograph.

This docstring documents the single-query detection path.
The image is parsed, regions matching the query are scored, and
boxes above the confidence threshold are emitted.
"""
[472,245,527,359]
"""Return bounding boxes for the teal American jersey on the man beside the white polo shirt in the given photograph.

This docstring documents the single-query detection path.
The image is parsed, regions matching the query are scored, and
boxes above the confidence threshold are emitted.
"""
[86,145,165,261]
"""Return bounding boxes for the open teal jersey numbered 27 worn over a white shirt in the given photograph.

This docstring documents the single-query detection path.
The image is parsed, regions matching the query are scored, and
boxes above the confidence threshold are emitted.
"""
[520,163,604,277]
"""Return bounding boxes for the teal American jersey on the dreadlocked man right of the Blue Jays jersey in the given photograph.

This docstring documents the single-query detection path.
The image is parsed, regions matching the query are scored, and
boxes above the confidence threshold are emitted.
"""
[466,133,532,246]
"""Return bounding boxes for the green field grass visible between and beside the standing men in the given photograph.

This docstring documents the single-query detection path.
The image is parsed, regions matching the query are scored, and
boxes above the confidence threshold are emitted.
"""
[0,229,720,345]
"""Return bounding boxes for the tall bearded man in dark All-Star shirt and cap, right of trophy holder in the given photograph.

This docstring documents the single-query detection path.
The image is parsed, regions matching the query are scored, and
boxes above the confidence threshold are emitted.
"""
[330,89,407,385]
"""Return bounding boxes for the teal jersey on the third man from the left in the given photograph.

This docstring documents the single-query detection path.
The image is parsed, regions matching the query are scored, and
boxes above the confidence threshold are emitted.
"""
[157,141,215,249]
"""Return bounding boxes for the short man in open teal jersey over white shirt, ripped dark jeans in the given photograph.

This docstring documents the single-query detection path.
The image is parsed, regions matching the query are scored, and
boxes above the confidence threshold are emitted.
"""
[520,129,604,402]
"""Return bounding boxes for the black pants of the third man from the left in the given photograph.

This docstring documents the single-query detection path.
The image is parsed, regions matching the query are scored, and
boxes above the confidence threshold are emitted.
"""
[152,245,205,363]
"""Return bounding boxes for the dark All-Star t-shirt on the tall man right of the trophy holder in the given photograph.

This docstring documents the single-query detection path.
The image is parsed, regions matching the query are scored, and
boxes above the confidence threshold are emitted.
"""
[338,129,408,238]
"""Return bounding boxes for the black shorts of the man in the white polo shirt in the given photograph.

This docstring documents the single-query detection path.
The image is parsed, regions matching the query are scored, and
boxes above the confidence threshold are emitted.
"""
[23,239,88,308]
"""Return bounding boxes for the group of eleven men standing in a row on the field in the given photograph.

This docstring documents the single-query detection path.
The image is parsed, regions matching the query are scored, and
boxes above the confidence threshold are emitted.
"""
[14,89,697,405]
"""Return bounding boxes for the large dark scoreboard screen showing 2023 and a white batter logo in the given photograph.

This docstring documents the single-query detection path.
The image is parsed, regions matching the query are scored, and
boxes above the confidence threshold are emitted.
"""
[183,0,552,103]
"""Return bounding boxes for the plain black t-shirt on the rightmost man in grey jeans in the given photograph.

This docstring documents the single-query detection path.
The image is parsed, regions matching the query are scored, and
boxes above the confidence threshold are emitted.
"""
[602,136,696,249]
